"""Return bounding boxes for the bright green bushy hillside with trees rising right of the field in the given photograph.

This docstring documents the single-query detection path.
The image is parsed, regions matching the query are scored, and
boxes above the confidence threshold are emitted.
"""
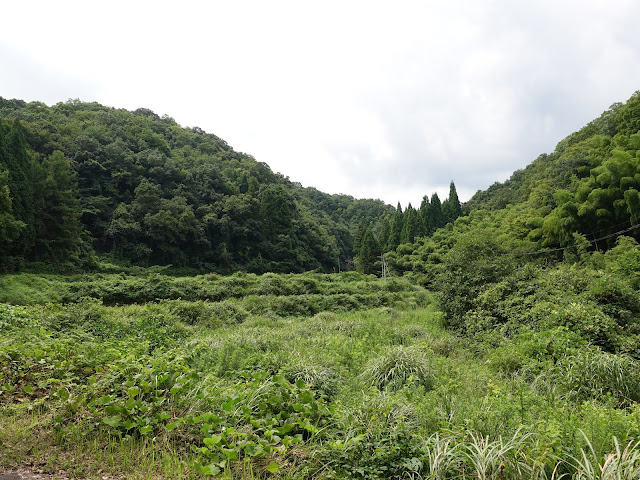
[387,93,640,360]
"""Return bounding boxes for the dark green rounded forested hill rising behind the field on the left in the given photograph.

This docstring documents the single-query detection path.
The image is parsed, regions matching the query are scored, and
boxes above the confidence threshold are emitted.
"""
[0,98,404,272]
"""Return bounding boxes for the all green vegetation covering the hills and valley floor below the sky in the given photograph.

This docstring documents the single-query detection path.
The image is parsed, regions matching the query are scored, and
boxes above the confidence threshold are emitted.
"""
[0,90,640,480]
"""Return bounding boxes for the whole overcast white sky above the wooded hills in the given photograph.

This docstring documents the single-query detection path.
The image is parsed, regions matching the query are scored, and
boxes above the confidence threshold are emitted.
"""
[0,0,640,206]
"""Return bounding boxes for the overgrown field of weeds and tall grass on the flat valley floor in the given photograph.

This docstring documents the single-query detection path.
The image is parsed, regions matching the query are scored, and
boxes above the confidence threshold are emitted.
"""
[0,271,640,480]
